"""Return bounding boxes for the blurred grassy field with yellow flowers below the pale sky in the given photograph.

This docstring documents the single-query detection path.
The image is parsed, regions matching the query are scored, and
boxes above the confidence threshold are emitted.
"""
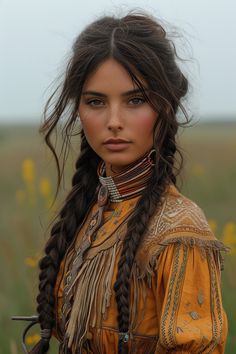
[0,122,236,354]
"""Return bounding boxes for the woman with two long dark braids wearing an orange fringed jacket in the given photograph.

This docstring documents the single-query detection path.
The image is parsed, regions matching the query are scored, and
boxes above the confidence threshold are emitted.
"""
[20,14,227,354]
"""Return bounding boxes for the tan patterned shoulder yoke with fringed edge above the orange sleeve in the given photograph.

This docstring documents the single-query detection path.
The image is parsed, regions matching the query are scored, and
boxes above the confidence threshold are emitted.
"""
[136,186,226,276]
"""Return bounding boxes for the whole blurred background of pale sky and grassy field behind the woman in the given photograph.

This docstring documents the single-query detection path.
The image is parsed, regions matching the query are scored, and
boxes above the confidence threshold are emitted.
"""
[0,0,236,354]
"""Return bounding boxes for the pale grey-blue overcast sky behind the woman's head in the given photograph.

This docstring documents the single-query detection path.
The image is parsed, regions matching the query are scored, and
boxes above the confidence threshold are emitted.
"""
[0,0,236,122]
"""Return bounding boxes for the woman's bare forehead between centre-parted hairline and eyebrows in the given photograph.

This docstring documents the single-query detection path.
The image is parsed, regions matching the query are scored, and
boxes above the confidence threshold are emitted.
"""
[83,59,145,94]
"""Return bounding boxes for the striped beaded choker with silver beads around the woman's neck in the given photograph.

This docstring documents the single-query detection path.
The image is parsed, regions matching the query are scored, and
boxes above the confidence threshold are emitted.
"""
[98,150,155,202]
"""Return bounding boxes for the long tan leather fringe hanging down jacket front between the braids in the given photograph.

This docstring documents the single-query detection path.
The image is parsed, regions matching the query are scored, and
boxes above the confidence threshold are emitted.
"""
[66,243,117,353]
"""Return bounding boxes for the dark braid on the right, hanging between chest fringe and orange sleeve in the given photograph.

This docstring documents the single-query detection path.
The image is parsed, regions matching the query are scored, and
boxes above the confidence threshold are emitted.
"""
[114,160,166,354]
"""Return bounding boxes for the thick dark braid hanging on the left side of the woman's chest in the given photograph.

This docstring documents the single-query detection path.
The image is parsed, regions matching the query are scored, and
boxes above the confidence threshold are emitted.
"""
[30,138,99,354]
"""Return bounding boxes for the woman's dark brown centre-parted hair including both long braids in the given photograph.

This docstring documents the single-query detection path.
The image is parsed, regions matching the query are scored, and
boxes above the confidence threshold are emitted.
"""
[32,13,188,354]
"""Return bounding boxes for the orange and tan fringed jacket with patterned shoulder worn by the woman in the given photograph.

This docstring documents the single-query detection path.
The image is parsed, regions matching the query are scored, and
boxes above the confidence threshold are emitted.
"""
[54,187,227,354]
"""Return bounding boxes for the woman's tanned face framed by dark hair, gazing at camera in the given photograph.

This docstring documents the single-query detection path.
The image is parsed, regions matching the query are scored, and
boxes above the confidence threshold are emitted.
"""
[79,59,157,176]
